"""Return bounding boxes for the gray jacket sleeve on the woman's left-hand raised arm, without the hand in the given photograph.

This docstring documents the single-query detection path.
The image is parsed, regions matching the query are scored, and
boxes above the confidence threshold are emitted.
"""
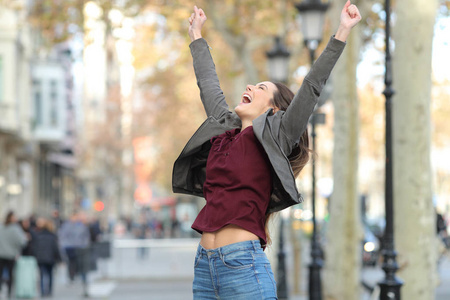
[189,38,229,119]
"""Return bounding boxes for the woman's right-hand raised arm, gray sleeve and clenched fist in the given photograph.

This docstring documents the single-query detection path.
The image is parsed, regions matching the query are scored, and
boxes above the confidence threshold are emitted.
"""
[281,1,361,142]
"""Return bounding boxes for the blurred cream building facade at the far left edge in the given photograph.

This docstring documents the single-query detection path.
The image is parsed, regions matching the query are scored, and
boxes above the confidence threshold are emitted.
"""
[0,1,34,218]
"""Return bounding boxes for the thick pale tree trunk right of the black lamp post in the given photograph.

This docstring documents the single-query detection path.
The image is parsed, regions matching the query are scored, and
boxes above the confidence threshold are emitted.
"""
[392,0,437,300]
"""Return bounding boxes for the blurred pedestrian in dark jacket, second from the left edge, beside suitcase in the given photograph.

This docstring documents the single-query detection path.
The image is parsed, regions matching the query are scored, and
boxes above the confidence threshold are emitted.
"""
[33,218,61,297]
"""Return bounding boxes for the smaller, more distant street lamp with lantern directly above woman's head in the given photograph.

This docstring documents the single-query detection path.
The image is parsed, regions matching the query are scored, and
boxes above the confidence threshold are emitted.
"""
[266,37,291,300]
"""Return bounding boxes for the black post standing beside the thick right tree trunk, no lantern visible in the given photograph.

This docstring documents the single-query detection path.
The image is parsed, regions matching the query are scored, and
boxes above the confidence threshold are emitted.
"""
[378,0,403,300]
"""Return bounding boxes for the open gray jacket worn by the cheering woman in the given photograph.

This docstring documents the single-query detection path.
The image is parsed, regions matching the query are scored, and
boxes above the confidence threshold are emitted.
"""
[172,37,345,213]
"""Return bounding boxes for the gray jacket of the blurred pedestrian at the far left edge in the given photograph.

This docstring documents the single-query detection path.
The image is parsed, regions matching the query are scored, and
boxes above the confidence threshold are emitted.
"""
[0,224,27,259]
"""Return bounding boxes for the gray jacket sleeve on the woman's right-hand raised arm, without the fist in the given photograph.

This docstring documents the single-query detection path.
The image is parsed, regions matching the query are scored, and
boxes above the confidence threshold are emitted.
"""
[281,37,346,144]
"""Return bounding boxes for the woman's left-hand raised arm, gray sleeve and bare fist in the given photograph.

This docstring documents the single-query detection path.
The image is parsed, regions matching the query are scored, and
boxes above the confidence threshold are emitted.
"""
[189,6,229,118]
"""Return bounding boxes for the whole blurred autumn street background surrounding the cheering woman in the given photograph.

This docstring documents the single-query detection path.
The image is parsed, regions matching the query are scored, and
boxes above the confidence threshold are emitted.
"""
[0,0,450,300]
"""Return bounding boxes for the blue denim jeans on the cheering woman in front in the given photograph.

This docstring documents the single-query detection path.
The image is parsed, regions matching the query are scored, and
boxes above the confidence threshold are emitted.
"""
[192,241,278,300]
